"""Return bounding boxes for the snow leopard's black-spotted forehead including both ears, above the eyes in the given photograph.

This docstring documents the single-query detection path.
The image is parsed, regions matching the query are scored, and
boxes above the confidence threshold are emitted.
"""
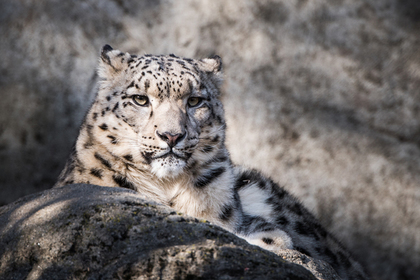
[98,45,222,100]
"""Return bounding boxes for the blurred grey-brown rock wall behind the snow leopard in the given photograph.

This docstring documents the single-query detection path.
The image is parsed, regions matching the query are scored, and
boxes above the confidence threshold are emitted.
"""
[0,0,420,279]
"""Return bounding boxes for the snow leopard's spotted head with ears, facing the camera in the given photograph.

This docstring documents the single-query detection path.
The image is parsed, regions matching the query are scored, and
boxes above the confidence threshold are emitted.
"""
[84,45,224,178]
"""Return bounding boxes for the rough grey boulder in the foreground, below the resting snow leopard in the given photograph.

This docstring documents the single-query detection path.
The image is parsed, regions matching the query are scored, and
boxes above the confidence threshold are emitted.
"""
[0,184,338,279]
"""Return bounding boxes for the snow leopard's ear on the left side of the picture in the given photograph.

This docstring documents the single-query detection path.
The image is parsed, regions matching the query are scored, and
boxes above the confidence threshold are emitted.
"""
[98,45,131,80]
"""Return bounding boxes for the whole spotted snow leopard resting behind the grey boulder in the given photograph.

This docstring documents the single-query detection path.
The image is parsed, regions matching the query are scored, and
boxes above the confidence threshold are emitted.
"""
[55,45,367,279]
